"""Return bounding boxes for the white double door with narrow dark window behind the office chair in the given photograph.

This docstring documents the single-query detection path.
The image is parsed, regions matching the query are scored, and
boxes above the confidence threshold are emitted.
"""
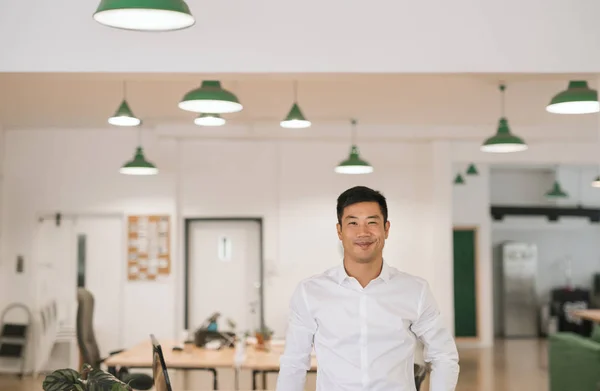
[35,215,126,357]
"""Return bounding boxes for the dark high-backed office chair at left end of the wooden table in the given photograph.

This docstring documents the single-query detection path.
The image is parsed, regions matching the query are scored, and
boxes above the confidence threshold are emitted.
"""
[77,288,153,391]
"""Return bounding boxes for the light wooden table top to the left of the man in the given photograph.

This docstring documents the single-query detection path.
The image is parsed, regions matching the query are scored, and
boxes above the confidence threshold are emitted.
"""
[104,340,317,370]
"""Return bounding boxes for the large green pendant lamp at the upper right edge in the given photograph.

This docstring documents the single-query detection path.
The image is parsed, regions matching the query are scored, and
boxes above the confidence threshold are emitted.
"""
[546,80,600,114]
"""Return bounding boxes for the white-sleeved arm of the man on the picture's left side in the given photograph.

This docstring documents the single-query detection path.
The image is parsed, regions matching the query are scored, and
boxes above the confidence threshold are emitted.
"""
[276,283,317,391]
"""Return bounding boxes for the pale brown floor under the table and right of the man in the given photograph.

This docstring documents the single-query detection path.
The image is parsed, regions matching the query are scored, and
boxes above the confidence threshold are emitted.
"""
[0,340,548,391]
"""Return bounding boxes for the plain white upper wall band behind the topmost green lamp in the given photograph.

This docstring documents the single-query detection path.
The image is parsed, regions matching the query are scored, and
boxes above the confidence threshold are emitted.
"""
[0,0,600,72]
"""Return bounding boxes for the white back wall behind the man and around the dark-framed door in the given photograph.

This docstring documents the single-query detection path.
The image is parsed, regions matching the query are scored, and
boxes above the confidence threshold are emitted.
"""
[0,129,453,370]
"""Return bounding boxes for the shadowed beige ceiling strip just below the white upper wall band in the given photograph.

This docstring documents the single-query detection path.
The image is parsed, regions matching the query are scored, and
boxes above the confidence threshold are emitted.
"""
[0,73,598,142]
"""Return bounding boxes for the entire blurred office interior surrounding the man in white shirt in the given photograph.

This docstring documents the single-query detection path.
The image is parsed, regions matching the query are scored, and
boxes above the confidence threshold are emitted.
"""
[0,0,600,391]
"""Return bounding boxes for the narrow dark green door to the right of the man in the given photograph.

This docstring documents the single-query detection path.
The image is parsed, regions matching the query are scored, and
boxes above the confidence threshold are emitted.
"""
[453,229,478,338]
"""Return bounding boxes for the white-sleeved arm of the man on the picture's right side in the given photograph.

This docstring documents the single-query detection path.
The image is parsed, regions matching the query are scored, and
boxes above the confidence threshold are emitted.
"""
[411,283,459,391]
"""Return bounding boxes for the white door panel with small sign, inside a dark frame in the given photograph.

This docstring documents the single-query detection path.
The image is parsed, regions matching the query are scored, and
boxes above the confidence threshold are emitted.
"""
[187,220,261,332]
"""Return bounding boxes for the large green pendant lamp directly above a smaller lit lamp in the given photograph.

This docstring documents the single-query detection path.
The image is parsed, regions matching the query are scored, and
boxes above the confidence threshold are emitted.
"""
[179,80,243,114]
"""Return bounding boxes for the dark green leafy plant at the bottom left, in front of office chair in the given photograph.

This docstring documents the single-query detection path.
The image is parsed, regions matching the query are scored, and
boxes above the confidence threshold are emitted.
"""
[42,364,132,391]
